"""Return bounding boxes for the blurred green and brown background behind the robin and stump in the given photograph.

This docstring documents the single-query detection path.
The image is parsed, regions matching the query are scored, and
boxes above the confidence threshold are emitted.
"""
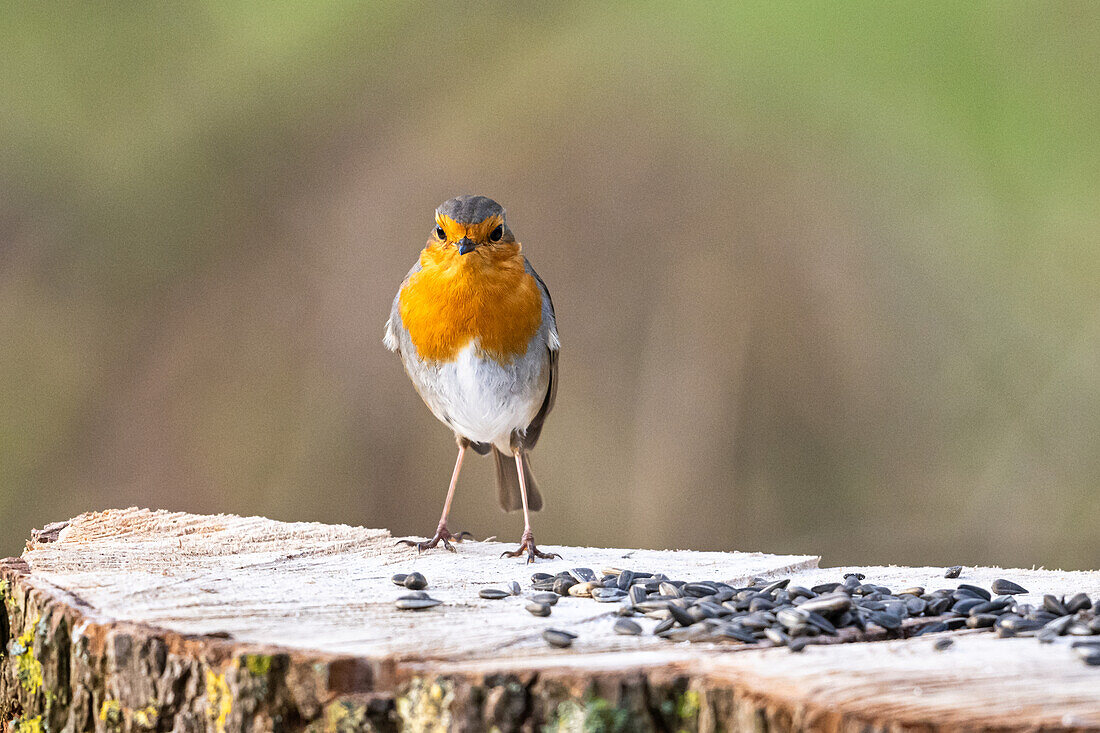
[0,1,1100,568]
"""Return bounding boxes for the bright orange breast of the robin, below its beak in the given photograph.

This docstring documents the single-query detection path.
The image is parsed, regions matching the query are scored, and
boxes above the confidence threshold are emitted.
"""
[400,243,542,363]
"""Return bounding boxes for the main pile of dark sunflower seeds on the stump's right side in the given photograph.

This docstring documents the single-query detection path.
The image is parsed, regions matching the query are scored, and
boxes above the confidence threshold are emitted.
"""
[528,568,1100,665]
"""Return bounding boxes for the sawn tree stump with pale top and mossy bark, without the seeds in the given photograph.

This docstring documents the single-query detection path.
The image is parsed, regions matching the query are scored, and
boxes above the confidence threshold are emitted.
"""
[0,510,1100,731]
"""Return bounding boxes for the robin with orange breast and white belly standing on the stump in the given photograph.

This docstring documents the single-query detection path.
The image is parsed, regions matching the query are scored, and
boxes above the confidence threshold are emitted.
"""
[385,196,560,562]
